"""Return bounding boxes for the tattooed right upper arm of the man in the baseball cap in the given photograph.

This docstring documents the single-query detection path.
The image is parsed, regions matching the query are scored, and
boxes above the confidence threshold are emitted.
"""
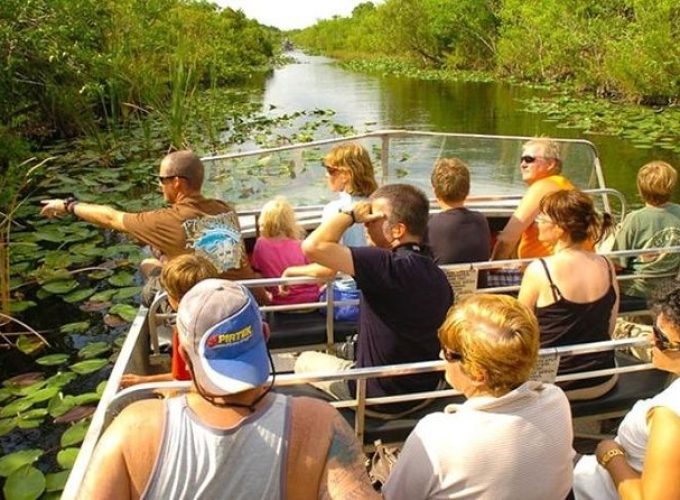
[319,412,380,499]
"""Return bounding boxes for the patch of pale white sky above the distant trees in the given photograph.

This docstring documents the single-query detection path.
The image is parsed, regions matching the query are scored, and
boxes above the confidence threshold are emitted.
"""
[213,0,377,30]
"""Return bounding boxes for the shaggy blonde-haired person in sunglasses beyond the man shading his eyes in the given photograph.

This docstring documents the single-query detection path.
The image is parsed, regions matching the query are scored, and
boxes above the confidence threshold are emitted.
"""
[321,142,378,246]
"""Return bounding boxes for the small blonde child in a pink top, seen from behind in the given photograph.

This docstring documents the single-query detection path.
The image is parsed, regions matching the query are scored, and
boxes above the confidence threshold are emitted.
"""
[252,196,319,305]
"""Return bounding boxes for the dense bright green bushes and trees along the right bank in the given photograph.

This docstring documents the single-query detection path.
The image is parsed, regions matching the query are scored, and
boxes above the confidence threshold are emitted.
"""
[293,0,680,104]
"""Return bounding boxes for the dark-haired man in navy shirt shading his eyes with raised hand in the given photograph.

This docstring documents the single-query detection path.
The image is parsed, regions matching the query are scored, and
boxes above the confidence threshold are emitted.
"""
[295,184,453,414]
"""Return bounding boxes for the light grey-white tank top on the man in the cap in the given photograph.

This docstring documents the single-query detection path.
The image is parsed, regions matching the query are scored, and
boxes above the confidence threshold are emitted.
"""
[142,393,290,500]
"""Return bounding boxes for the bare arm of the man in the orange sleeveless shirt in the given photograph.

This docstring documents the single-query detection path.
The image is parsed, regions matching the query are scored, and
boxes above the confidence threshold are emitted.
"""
[491,181,558,260]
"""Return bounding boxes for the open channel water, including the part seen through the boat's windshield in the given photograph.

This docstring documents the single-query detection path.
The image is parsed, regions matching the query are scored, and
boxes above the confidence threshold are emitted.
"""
[215,52,680,207]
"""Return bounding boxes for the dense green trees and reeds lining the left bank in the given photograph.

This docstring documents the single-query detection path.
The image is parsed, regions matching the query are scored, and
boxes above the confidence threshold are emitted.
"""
[0,0,278,152]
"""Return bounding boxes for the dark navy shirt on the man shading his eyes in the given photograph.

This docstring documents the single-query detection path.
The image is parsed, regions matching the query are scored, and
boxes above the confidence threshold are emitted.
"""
[350,244,453,412]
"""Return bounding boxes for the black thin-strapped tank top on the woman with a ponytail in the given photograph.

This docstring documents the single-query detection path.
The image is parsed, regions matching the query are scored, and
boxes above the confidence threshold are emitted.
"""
[536,257,616,389]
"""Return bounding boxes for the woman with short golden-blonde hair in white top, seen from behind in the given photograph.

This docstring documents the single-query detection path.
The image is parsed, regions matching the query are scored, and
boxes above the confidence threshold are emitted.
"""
[383,294,574,500]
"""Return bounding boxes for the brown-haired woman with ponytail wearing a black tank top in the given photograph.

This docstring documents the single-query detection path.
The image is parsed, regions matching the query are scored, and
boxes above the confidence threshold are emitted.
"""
[519,189,619,400]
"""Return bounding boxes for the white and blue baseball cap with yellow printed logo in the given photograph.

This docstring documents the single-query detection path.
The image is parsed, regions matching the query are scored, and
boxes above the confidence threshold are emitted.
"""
[177,279,269,395]
